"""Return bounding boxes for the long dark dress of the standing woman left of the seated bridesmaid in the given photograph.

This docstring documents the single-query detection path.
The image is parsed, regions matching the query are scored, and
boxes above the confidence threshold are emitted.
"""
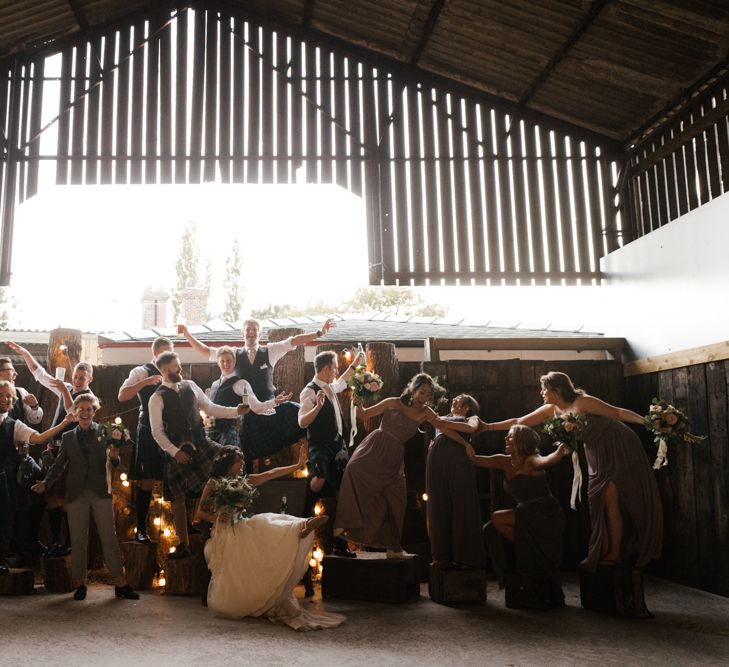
[425,417,486,568]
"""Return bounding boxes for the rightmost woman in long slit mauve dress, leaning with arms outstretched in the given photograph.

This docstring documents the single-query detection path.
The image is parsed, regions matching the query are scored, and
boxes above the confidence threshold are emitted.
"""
[481,372,663,571]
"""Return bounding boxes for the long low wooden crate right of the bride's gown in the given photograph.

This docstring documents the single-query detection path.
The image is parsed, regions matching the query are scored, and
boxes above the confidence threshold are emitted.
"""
[321,551,420,602]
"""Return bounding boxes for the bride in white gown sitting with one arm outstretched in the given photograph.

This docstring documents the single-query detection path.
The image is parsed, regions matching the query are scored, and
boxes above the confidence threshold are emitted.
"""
[196,445,346,631]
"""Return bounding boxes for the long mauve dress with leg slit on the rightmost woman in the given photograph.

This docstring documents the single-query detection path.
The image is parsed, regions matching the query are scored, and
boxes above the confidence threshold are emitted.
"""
[582,414,663,570]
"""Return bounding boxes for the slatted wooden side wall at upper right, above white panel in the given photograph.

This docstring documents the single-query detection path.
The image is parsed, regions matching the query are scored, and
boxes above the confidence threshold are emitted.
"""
[622,77,729,235]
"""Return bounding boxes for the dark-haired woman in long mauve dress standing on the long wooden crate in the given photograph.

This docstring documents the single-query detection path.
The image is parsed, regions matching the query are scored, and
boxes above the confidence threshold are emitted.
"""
[334,373,473,558]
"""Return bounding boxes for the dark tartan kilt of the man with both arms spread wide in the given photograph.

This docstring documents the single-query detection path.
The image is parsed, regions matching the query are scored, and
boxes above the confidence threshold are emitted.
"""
[240,401,306,459]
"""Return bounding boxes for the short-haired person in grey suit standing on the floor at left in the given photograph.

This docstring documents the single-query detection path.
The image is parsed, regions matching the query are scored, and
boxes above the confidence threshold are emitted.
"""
[32,394,139,600]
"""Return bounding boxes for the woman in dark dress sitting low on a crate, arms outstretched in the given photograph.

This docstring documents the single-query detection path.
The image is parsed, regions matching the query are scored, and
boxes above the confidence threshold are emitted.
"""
[474,425,568,606]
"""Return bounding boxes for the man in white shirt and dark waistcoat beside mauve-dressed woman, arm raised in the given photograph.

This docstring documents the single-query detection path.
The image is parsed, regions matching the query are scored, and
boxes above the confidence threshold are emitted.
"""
[299,351,360,558]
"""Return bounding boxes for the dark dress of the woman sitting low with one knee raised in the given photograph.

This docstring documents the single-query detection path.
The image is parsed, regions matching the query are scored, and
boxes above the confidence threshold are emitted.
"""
[484,475,565,605]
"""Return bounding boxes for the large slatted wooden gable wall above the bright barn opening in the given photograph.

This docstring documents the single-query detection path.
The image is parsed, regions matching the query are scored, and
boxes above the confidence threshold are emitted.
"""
[4,8,624,284]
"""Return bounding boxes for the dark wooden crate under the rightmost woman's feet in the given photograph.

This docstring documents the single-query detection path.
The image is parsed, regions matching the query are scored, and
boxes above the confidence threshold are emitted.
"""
[580,563,653,618]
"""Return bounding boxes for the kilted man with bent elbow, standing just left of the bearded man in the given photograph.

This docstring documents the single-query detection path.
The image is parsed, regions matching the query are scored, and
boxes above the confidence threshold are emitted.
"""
[117,336,173,542]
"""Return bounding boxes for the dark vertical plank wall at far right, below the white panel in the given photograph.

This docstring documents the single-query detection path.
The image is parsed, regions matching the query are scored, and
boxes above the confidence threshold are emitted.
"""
[625,361,729,595]
